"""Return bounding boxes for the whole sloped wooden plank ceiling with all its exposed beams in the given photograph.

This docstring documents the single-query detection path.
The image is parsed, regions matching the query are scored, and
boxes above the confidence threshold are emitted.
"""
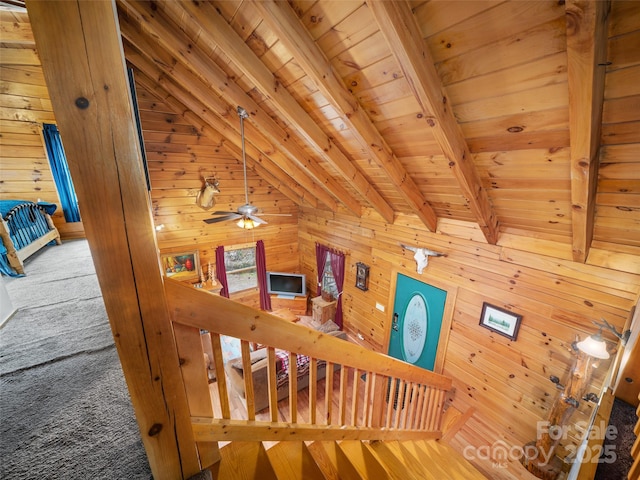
[5,0,640,262]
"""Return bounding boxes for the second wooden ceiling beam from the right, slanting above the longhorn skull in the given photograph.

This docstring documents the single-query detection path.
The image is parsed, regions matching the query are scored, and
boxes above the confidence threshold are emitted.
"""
[367,0,499,244]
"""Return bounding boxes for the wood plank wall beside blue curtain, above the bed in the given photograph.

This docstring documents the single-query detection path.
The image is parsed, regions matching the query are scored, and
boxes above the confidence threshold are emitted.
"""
[0,11,84,239]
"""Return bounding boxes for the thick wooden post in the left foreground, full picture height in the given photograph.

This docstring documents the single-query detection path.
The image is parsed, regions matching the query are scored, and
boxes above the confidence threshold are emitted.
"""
[27,0,201,480]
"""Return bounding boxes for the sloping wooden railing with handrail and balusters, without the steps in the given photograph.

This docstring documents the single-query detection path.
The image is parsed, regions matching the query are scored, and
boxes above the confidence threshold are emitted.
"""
[165,280,452,442]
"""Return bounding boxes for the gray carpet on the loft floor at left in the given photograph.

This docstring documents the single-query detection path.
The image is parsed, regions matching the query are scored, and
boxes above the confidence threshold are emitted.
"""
[0,240,151,479]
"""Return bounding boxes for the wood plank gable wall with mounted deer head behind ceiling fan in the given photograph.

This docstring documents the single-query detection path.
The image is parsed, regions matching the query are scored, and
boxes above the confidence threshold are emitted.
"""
[136,85,300,296]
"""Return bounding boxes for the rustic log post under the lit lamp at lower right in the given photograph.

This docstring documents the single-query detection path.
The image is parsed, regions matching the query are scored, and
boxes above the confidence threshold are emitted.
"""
[521,344,597,480]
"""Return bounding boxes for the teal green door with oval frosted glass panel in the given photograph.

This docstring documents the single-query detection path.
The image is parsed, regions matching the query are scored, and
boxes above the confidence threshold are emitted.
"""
[389,273,447,370]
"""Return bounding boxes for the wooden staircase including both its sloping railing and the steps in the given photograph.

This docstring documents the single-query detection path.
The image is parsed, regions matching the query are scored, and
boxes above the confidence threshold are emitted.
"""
[165,279,485,480]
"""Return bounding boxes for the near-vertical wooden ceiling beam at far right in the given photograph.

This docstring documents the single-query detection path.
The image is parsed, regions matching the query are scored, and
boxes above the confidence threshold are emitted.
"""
[565,0,611,263]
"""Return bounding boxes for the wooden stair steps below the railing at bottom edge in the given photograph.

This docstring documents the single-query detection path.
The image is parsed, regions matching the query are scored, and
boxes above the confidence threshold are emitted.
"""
[209,440,486,480]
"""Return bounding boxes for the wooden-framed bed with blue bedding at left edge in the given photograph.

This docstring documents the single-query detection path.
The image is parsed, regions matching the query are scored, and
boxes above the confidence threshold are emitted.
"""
[0,200,61,277]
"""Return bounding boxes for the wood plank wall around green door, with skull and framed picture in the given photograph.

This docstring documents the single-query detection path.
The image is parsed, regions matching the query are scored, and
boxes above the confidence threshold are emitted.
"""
[300,209,640,478]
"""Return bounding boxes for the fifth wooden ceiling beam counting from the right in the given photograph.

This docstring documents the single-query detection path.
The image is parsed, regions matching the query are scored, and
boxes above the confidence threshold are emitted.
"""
[119,0,352,213]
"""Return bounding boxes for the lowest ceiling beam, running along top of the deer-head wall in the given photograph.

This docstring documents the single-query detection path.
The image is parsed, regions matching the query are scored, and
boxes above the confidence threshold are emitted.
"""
[131,68,318,208]
